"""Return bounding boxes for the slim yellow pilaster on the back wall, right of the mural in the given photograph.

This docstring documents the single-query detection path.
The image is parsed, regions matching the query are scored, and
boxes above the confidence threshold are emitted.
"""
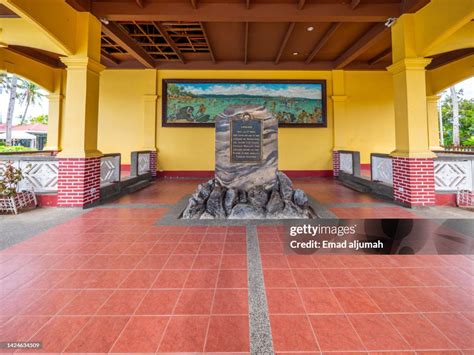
[331,70,347,151]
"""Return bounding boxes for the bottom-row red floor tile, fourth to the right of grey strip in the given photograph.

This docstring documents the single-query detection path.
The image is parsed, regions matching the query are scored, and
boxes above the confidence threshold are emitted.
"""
[386,314,455,350]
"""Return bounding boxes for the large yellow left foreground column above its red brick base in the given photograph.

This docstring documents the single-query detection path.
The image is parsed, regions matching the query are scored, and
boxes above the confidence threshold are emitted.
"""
[60,13,104,158]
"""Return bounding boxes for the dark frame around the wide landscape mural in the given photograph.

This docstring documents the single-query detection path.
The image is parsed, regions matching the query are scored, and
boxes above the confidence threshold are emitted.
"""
[161,79,327,128]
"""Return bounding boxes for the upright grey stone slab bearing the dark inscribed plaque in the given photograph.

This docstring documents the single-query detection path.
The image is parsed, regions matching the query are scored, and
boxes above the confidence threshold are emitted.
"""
[216,106,278,191]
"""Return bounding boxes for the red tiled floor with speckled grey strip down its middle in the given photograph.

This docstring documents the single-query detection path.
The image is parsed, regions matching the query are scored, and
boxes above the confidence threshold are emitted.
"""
[0,181,474,354]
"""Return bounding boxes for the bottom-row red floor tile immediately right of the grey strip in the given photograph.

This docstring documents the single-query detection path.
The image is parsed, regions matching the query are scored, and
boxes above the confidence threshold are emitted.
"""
[270,315,319,352]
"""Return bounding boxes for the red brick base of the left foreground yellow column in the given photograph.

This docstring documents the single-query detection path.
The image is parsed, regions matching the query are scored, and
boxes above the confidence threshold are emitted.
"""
[58,157,100,207]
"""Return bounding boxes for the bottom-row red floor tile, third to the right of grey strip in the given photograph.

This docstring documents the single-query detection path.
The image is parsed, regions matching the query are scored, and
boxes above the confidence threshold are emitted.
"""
[348,314,410,351]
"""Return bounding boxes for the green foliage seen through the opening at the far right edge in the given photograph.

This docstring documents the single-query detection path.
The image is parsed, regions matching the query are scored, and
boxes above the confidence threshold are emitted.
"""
[441,90,474,146]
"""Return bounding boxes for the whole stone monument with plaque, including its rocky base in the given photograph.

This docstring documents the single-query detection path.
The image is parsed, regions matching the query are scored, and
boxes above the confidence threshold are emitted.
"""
[182,106,315,219]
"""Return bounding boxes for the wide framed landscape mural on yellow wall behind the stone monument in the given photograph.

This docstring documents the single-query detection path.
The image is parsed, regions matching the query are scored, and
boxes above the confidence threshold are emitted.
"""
[162,80,326,127]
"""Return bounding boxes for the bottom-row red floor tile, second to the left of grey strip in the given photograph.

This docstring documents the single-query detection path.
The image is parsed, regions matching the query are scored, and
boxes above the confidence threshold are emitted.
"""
[159,316,209,352]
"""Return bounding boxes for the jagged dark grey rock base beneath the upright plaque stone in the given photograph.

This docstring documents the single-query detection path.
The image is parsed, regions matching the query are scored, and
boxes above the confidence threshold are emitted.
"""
[181,172,317,219]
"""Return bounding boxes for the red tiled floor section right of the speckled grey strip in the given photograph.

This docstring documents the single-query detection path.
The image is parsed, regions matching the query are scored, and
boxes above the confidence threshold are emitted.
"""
[258,226,474,354]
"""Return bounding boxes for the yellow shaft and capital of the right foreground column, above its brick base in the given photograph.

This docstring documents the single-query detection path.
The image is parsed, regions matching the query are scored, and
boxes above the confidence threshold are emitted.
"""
[387,58,434,158]
